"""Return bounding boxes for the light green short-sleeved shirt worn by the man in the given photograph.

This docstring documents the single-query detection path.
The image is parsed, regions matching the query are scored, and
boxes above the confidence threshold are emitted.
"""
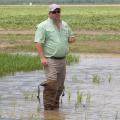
[34,18,73,57]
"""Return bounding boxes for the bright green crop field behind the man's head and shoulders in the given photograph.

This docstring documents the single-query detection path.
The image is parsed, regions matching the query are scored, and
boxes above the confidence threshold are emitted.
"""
[0,5,120,31]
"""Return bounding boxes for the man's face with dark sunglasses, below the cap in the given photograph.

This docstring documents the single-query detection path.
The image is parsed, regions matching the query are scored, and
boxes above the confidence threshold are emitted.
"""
[49,8,61,21]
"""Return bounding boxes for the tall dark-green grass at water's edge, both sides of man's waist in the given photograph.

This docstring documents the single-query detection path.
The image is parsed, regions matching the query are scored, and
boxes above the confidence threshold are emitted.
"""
[0,53,79,76]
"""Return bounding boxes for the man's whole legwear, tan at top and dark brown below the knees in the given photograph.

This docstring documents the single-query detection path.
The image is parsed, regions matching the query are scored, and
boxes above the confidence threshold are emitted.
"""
[41,58,66,110]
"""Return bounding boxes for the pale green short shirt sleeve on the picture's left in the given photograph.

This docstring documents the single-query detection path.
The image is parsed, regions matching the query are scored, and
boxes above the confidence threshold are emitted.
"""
[34,25,45,43]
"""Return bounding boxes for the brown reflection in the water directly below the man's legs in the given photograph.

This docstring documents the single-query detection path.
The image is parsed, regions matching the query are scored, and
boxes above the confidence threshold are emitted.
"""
[44,111,65,120]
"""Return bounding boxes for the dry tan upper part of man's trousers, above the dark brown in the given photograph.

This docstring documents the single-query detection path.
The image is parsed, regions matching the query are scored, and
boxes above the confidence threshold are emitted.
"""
[44,58,66,89]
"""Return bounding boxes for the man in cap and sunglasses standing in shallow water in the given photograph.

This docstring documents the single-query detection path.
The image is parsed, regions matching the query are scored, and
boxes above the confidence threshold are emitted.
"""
[34,4,75,110]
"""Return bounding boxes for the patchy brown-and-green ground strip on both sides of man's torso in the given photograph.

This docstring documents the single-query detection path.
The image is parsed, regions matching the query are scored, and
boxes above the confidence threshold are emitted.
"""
[0,32,120,53]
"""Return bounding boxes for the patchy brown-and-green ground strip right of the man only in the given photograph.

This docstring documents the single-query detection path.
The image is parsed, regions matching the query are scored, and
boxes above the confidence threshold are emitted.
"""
[70,34,120,53]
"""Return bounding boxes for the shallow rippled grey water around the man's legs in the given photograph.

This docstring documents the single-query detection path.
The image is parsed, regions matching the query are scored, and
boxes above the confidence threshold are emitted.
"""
[0,55,120,120]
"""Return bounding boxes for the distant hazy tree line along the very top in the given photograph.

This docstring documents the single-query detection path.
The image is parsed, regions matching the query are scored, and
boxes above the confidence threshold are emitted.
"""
[0,0,120,5]
